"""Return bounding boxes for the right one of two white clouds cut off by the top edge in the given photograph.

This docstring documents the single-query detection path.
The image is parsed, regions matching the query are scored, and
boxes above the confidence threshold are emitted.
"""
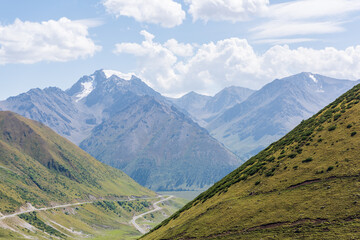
[185,0,269,22]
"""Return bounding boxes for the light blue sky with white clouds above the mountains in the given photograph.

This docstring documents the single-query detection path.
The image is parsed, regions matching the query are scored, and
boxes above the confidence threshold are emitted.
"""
[0,0,360,100]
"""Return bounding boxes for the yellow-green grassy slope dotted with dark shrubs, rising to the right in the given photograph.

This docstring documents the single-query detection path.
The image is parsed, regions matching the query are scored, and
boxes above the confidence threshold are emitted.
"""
[144,85,360,239]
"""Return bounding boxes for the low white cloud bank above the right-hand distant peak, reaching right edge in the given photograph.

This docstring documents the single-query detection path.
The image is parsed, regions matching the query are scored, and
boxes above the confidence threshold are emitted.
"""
[261,45,360,80]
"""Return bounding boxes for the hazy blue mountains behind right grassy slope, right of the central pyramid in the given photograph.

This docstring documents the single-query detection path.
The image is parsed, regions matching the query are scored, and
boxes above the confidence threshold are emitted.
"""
[174,72,359,160]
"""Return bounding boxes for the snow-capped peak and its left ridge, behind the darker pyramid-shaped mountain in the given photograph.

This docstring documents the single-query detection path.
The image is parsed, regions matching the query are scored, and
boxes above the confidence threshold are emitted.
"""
[0,70,162,144]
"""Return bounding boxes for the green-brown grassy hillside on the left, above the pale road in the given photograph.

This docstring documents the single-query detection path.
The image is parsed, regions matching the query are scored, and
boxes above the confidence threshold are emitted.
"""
[0,112,154,214]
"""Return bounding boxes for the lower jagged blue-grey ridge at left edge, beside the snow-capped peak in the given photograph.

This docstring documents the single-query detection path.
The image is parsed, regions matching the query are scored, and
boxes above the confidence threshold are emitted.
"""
[0,87,94,143]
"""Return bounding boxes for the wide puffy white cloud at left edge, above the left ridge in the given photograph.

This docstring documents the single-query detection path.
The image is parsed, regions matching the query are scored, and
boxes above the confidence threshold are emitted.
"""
[0,18,101,64]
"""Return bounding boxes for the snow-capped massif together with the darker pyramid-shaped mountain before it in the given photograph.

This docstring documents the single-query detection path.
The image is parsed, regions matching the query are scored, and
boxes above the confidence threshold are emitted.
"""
[0,70,241,190]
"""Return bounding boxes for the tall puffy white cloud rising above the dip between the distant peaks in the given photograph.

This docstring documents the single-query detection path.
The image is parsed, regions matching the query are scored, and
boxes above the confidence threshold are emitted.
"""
[176,38,261,94]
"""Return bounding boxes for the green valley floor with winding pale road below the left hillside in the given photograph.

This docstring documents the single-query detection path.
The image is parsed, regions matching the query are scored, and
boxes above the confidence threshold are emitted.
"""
[0,196,187,239]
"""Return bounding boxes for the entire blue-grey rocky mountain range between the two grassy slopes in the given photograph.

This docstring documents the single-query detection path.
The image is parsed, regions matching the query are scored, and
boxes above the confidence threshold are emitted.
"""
[0,70,357,190]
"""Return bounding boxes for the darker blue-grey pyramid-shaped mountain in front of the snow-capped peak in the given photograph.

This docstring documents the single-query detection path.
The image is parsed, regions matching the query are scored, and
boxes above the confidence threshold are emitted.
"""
[80,93,240,190]
